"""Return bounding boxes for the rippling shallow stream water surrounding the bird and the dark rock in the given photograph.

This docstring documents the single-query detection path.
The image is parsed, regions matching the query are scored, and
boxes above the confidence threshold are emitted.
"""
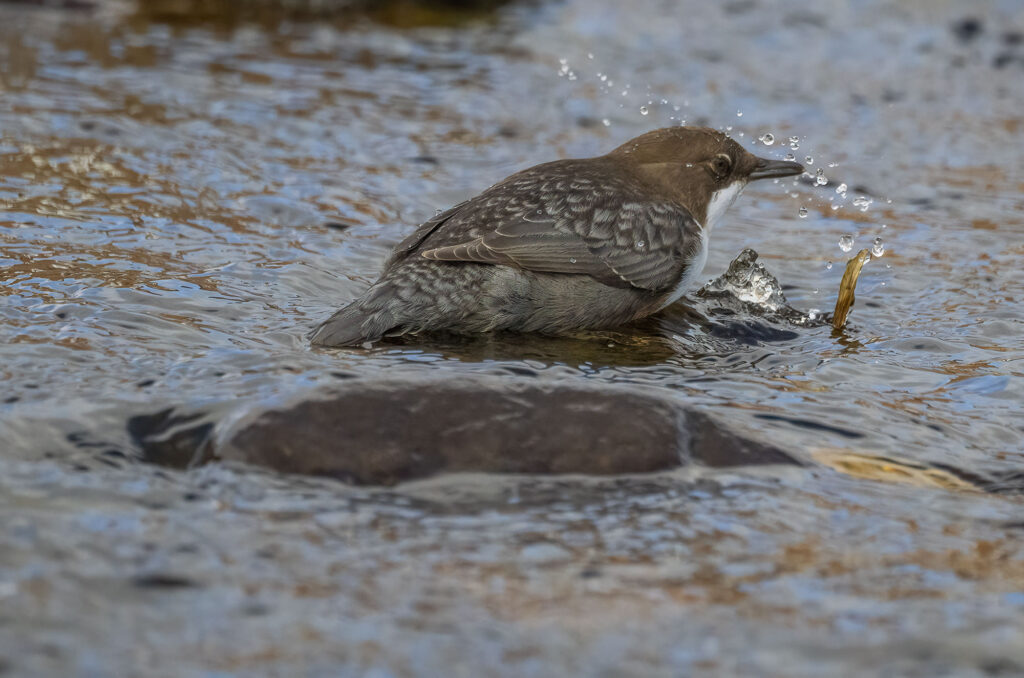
[0,0,1024,676]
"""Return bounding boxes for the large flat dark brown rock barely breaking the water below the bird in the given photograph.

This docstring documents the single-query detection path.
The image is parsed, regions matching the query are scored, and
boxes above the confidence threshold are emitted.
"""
[215,377,800,484]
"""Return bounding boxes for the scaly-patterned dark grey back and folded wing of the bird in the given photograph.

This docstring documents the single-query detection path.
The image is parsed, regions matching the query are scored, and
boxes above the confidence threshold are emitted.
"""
[417,161,700,291]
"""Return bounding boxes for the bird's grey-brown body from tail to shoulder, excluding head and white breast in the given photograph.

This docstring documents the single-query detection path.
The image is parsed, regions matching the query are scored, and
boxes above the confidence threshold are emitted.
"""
[313,157,700,345]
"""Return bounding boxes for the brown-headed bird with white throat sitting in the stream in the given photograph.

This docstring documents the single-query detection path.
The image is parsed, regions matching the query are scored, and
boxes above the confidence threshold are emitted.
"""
[309,126,804,347]
